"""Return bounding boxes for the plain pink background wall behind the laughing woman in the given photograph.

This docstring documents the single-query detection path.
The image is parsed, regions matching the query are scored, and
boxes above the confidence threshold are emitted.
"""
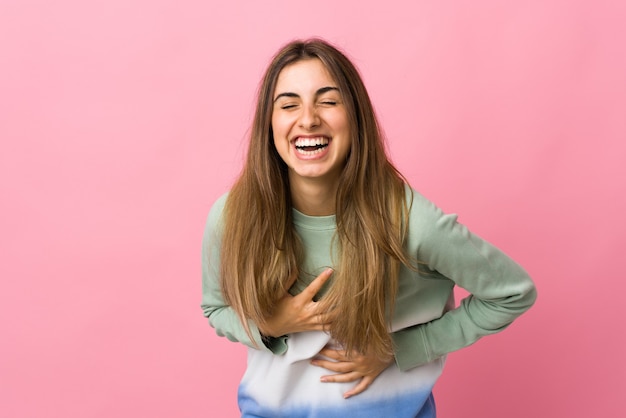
[0,0,626,418]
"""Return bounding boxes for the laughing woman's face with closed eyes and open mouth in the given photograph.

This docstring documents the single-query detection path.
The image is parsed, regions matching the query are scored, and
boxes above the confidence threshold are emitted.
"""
[272,59,350,187]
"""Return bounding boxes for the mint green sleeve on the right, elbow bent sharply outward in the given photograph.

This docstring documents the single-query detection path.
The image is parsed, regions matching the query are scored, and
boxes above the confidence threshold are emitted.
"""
[392,193,537,370]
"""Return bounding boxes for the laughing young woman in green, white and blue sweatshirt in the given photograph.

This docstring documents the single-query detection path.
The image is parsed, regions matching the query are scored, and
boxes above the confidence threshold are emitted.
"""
[202,39,536,418]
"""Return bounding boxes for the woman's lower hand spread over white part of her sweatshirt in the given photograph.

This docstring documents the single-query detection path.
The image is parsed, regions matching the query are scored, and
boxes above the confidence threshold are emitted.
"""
[311,347,393,399]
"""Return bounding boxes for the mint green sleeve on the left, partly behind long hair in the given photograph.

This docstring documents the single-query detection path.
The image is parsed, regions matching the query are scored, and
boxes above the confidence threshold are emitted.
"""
[201,195,287,354]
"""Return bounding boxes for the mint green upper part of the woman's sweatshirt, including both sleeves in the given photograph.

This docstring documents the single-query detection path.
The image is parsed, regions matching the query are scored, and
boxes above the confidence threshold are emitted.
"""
[202,186,536,371]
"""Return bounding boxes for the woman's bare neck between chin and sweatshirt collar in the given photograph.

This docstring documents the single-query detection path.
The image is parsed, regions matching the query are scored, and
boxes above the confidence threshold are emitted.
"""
[290,178,337,216]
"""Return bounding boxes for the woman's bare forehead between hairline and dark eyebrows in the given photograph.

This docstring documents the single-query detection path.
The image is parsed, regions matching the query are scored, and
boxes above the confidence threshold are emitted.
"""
[274,58,337,96]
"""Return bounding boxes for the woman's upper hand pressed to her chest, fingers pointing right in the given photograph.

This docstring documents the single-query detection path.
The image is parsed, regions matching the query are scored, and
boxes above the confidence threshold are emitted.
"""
[260,268,333,337]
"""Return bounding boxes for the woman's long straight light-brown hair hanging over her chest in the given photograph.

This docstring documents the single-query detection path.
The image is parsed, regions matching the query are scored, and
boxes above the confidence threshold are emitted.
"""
[220,39,412,357]
